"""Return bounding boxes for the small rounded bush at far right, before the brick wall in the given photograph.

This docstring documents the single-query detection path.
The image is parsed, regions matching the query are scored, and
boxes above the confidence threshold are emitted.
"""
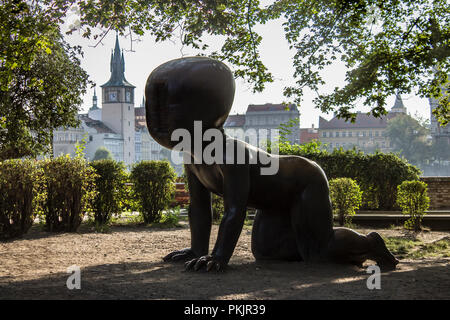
[397,181,430,231]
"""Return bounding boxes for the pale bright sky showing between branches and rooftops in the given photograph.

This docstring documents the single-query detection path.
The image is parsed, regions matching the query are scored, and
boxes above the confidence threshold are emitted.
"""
[63,16,430,128]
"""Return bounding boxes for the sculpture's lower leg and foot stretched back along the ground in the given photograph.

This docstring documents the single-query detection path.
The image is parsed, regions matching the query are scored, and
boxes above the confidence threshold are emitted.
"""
[328,228,398,270]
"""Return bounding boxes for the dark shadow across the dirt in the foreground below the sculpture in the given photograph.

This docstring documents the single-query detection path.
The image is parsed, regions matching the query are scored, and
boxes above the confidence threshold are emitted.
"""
[0,261,450,299]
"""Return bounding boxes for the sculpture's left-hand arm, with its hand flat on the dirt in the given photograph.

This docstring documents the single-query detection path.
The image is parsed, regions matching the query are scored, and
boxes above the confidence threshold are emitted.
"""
[164,165,212,261]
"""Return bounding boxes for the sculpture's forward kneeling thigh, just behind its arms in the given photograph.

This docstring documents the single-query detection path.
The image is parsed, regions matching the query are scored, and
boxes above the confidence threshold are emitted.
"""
[252,210,301,261]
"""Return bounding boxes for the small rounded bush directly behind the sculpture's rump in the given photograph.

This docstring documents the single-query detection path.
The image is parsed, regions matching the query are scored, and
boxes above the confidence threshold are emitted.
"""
[330,178,362,226]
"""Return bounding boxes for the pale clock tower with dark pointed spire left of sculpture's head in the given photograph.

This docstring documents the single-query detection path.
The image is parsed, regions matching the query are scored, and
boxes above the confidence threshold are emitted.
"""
[101,34,136,165]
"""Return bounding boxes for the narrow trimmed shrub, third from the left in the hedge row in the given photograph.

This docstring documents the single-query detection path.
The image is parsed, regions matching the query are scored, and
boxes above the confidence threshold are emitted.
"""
[90,159,128,225]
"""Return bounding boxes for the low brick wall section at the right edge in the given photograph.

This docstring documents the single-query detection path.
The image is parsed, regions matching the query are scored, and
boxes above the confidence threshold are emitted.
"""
[420,177,450,210]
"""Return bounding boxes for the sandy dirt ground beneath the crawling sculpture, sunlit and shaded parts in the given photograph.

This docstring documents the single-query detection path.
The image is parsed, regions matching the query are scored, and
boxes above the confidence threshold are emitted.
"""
[0,225,450,299]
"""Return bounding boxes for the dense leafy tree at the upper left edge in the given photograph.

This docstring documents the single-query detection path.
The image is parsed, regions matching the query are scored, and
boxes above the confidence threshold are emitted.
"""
[0,1,88,160]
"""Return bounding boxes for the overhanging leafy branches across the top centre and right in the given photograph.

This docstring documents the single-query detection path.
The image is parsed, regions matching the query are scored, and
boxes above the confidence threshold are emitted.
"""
[67,0,450,123]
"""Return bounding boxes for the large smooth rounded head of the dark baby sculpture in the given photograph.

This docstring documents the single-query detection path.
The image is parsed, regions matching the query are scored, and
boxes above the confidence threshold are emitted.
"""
[145,57,235,149]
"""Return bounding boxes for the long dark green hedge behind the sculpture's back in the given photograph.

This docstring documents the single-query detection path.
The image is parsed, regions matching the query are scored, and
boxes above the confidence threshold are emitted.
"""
[279,142,420,210]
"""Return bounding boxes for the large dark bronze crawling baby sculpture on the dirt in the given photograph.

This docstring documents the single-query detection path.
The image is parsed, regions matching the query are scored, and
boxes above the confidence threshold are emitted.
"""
[145,57,398,271]
